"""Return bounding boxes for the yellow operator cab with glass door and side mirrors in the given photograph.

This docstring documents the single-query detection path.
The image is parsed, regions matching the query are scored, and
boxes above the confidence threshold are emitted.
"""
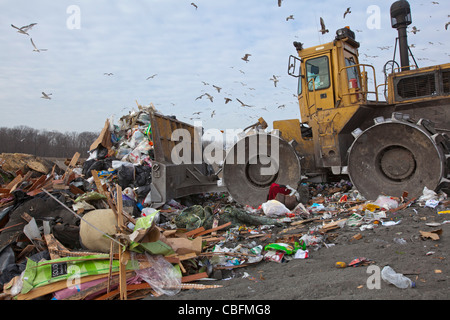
[288,27,366,124]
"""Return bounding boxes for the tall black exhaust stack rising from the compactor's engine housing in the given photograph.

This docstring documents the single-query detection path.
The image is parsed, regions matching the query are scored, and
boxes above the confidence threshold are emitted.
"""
[391,0,412,71]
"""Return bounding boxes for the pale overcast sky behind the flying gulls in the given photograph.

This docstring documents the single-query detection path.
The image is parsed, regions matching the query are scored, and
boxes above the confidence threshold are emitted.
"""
[0,0,450,132]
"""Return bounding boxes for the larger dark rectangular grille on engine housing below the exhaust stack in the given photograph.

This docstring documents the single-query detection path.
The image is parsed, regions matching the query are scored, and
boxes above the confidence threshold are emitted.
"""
[397,73,437,99]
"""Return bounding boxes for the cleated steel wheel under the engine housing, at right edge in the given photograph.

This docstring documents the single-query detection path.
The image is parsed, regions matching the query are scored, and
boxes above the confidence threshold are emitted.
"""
[348,117,448,200]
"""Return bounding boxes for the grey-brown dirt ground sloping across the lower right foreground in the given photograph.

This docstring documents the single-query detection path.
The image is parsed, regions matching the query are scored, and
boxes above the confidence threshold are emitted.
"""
[149,204,450,305]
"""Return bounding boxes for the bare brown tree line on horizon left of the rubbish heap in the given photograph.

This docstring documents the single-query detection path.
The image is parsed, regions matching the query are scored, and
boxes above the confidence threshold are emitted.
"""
[0,126,99,158]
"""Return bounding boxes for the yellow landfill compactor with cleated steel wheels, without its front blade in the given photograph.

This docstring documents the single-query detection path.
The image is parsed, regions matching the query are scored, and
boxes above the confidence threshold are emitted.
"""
[223,0,450,205]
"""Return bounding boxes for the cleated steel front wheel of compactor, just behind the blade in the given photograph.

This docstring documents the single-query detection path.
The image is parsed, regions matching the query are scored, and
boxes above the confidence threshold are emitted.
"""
[223,133,301,208]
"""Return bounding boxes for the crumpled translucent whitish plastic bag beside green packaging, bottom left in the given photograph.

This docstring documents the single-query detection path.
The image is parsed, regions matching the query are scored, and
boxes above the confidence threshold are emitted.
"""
[132,252,181,296]
